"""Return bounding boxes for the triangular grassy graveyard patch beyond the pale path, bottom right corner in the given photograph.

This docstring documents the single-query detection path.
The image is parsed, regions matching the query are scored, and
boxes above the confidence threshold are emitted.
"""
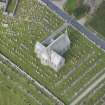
[78,80,105,105]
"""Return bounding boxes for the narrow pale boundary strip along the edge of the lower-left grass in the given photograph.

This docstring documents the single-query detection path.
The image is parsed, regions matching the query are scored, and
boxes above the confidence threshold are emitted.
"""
[0,53,65,105]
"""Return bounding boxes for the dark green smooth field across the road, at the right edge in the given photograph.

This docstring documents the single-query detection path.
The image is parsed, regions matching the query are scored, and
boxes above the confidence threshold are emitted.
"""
[87,2,105,37]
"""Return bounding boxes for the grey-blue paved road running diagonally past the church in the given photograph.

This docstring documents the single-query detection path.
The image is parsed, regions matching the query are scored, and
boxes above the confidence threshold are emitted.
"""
[41,0,105,50]
